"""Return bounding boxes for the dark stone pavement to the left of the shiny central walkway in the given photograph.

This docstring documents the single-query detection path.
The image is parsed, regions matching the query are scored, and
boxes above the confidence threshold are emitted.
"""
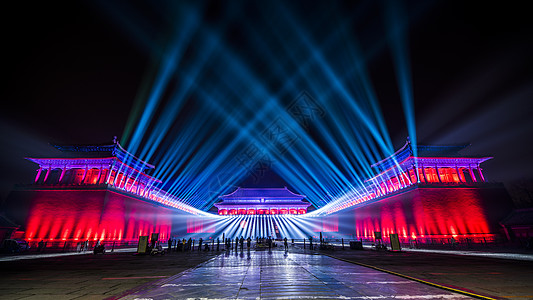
[0,251,220,300]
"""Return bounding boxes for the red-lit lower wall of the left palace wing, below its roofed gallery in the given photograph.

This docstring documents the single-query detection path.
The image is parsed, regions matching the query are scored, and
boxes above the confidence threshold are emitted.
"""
[8,189,172,241]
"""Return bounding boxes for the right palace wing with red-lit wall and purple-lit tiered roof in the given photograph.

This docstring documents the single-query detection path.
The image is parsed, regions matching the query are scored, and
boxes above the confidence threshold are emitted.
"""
[316,140,512,242]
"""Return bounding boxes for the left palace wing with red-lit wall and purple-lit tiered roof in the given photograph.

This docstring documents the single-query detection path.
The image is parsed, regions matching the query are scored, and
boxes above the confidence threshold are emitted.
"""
[6,141,202,242]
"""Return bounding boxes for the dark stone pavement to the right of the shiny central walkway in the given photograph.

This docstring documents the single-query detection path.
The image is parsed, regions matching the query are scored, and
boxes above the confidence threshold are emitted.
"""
[322,249,533,299]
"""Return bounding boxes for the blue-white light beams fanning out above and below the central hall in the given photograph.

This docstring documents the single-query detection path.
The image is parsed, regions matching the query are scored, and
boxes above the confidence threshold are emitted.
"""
[93,1,422,216]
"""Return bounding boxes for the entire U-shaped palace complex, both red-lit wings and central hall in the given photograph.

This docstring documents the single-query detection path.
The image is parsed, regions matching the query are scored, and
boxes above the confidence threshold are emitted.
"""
[3,141,511,243]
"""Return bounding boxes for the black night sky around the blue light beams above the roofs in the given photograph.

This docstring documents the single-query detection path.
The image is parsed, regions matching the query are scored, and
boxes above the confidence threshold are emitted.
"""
[0,1,533,206]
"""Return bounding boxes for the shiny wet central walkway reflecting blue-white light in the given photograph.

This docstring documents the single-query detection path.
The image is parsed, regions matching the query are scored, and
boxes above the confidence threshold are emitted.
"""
[121,250,470,300]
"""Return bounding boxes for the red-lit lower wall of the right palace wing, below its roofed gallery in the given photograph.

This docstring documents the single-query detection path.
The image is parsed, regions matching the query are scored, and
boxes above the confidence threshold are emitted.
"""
[336,186,511,239]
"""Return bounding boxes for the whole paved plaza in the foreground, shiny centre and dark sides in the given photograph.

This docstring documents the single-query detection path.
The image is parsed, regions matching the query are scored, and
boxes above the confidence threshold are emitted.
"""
[0,248,533,299]
